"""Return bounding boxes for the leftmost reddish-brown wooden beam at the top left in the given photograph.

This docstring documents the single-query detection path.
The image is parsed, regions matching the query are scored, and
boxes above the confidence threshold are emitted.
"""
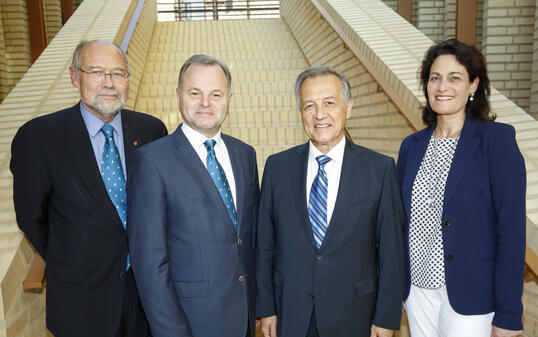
[26,0,47,63]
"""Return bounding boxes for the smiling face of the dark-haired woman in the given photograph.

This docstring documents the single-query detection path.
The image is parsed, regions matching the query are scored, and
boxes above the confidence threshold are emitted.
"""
[427,55,478,118]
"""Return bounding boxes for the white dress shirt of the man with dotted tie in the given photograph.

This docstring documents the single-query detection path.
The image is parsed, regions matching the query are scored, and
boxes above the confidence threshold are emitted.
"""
[181,123,238,207]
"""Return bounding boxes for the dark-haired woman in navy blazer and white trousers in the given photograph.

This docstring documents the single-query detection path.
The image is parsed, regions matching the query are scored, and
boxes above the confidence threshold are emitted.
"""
[398,39,526,337]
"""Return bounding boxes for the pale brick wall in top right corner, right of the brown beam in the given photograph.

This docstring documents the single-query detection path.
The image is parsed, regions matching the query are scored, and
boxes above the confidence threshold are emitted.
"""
[482,0,536,111]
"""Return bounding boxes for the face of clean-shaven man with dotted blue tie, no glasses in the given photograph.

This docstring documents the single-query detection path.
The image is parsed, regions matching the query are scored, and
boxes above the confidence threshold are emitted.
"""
[176,64,231,138]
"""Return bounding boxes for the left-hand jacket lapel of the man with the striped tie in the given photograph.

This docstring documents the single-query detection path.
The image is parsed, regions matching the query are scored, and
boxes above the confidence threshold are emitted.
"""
[289,143,318,250]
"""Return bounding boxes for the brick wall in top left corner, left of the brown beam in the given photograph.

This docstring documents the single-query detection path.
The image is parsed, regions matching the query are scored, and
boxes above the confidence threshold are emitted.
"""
[0,0,31,97]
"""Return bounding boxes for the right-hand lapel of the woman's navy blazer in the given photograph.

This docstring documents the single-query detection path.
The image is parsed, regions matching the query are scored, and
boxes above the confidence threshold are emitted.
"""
[443,119,481,207]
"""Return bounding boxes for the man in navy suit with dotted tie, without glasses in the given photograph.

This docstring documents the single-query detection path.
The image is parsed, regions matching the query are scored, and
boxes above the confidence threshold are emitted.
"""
[128,55,259,337]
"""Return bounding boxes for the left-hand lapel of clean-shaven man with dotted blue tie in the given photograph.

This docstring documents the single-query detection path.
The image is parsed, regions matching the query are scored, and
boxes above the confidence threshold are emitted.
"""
[172,124,239,235]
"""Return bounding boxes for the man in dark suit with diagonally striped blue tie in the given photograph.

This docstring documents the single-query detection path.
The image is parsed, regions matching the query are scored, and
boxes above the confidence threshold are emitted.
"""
[256,67,404,337]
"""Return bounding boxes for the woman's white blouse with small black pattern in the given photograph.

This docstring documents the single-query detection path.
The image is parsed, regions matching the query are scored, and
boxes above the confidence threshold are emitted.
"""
[409,136,459,289]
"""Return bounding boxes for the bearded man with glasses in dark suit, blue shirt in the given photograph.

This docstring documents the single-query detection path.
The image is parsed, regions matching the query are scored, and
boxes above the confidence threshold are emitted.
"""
[11,40,167,337]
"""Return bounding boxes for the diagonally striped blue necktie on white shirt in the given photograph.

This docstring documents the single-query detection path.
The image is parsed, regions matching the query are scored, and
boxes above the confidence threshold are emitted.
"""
[308,155,331,249]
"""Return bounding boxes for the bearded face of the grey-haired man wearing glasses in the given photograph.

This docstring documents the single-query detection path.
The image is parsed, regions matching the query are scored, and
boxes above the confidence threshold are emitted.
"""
[69,42,129,123]
